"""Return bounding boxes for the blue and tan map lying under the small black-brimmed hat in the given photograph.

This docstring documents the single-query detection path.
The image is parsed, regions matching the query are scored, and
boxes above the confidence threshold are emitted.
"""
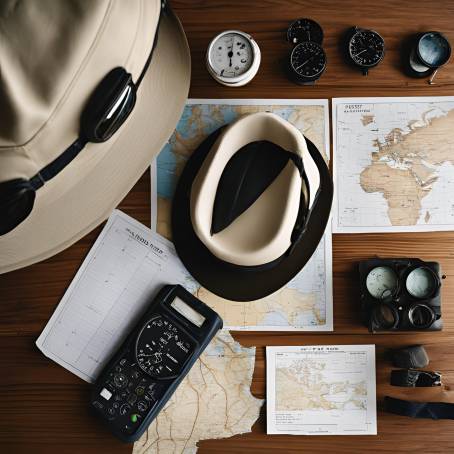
[151,99,333,331]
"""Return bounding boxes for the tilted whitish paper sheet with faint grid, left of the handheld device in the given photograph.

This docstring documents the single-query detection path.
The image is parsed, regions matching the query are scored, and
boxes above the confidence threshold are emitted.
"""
[36,210,193,382]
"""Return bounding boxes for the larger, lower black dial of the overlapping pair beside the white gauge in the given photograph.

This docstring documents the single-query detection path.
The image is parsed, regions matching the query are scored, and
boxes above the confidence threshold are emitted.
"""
[289,41,326,83]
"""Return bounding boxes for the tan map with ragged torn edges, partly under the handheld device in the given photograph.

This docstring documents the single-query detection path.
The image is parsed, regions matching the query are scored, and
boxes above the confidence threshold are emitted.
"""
[133,330,263,454]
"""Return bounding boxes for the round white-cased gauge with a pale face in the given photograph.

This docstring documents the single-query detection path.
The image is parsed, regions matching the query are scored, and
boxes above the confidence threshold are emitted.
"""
[206,30,260,87]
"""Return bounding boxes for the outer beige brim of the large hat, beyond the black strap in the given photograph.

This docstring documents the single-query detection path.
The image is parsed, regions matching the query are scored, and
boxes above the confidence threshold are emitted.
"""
[0,10,191,273]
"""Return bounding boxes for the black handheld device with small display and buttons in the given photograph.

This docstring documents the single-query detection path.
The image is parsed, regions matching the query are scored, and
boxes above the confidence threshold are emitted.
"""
[90,285,222,442]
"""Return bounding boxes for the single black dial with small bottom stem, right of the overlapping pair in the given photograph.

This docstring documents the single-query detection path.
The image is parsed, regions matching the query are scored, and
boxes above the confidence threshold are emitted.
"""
[348,28,385,74]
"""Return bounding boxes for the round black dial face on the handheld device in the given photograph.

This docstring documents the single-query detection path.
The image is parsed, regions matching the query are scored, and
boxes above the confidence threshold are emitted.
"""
[136,315,193,378]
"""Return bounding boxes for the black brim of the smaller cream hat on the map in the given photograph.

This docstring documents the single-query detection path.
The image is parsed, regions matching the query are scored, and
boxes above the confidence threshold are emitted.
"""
[172,122,333,301]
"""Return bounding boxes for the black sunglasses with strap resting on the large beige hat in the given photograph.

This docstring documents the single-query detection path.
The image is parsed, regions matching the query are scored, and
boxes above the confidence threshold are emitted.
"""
[0,2,167,235]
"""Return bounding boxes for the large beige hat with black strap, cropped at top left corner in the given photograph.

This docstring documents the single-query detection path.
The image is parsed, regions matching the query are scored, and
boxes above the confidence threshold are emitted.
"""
[0,0,190,272]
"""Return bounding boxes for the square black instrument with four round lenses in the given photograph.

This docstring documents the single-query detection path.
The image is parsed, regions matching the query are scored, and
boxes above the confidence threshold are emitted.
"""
[359,258,442,332]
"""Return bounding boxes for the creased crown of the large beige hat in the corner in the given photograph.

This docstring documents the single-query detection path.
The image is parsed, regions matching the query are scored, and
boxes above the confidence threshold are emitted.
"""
[0,0,109,146]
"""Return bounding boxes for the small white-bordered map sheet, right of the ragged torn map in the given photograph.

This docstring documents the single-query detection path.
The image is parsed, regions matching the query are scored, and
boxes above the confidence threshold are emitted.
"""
[266,345,377,435]
